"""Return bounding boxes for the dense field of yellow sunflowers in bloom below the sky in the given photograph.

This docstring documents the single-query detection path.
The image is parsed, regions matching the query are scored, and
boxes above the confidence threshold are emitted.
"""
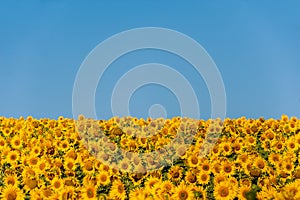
[0,115,300,200]
